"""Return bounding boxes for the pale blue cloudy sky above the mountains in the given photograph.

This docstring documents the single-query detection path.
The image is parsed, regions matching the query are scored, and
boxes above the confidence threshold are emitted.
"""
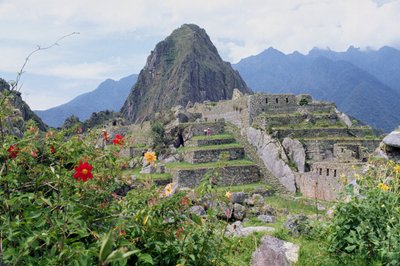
[0,0,400,109]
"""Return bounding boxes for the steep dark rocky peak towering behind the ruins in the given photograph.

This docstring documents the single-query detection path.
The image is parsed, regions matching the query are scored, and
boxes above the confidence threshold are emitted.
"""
[121,24,251,122]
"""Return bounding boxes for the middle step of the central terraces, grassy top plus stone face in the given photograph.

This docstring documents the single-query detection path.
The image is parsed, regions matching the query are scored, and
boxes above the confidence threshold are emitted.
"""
[178,143,245,164]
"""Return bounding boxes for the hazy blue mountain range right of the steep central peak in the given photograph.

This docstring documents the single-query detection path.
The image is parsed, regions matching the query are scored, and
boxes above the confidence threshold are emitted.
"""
[233,47,400,131]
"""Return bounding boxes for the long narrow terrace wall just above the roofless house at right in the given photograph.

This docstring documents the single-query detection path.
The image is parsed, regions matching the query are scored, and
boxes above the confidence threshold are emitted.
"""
[272,127,373,139]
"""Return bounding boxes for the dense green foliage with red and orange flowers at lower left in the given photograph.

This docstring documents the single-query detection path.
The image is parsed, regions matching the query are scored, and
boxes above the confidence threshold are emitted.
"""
[0,121,228,265]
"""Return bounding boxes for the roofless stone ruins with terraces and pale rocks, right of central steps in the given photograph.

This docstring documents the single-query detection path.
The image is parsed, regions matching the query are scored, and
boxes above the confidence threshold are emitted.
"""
[182,90,380,200]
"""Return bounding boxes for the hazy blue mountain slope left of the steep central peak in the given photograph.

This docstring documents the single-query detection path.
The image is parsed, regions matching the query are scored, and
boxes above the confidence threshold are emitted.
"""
[35,74,138,127]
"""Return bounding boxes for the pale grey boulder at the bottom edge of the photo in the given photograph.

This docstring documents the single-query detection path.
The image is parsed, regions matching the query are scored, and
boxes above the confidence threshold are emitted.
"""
[251,236,300,266]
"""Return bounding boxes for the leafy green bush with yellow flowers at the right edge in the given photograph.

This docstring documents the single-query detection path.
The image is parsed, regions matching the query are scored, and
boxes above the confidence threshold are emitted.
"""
[329,160,400,265]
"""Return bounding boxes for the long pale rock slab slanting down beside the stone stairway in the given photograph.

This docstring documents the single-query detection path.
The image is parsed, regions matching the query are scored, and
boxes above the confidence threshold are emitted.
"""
[245,127,296,192]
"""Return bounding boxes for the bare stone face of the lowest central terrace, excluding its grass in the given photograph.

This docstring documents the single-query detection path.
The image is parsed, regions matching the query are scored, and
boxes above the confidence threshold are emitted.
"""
[172,165,260,188]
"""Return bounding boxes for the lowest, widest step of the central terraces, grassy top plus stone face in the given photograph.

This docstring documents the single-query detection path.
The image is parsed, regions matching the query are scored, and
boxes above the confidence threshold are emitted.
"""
[166,160,261,188]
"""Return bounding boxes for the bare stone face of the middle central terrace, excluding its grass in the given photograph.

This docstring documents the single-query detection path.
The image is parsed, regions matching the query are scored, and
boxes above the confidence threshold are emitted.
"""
[183,147,244,164]
